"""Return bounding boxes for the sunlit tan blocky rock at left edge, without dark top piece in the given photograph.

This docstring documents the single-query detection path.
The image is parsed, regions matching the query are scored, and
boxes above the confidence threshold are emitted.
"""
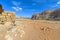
[0,11,16,23]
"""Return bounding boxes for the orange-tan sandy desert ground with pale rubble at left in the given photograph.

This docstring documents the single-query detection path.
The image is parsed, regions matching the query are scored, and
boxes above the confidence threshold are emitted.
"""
[0,20,60,40]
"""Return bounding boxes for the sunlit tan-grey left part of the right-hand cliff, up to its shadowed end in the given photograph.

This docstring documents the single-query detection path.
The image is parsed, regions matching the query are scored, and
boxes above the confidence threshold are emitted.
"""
[32,10,53,19]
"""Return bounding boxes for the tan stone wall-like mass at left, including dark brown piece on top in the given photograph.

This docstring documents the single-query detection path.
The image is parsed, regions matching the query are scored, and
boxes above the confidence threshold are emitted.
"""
[0,4,16,24]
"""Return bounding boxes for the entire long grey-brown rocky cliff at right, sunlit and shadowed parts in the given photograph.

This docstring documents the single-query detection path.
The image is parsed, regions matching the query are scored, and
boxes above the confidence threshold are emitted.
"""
[31,9,60,20]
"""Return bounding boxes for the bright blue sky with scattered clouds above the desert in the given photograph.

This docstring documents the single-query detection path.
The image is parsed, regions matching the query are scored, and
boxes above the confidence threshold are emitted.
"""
[0,0,60,17]
